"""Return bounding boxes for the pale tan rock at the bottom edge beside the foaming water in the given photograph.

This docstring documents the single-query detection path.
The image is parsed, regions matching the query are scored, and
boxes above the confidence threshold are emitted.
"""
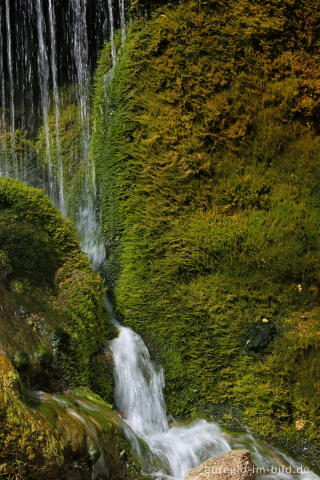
[185,450,255,480]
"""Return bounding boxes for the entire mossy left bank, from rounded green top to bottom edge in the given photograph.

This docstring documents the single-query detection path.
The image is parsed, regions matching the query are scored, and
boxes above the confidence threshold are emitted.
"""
[0,178,140,480]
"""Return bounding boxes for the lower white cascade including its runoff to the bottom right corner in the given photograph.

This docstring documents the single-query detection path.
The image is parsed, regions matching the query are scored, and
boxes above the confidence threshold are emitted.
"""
[110,325,319,480]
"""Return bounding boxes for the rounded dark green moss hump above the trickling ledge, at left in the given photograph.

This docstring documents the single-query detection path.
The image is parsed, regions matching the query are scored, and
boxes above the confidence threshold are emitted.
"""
[0,178,114,399]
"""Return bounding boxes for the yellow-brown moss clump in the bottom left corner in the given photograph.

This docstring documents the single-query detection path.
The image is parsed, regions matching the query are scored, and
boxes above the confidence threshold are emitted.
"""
[0,355,63,478]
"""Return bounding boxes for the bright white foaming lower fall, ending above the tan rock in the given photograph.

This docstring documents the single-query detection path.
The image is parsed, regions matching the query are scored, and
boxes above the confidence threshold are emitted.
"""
[110,327,230,480]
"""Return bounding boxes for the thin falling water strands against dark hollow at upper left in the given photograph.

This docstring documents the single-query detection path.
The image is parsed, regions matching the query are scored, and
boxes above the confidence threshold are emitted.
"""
[0,0,125,269]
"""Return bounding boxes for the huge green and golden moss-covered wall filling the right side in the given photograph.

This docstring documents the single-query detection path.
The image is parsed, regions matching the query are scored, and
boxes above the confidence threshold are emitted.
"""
[92,0,320,466]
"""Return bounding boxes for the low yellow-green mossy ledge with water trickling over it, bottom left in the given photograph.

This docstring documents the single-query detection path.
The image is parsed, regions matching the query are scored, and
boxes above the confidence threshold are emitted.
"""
[0,355,142,480]
